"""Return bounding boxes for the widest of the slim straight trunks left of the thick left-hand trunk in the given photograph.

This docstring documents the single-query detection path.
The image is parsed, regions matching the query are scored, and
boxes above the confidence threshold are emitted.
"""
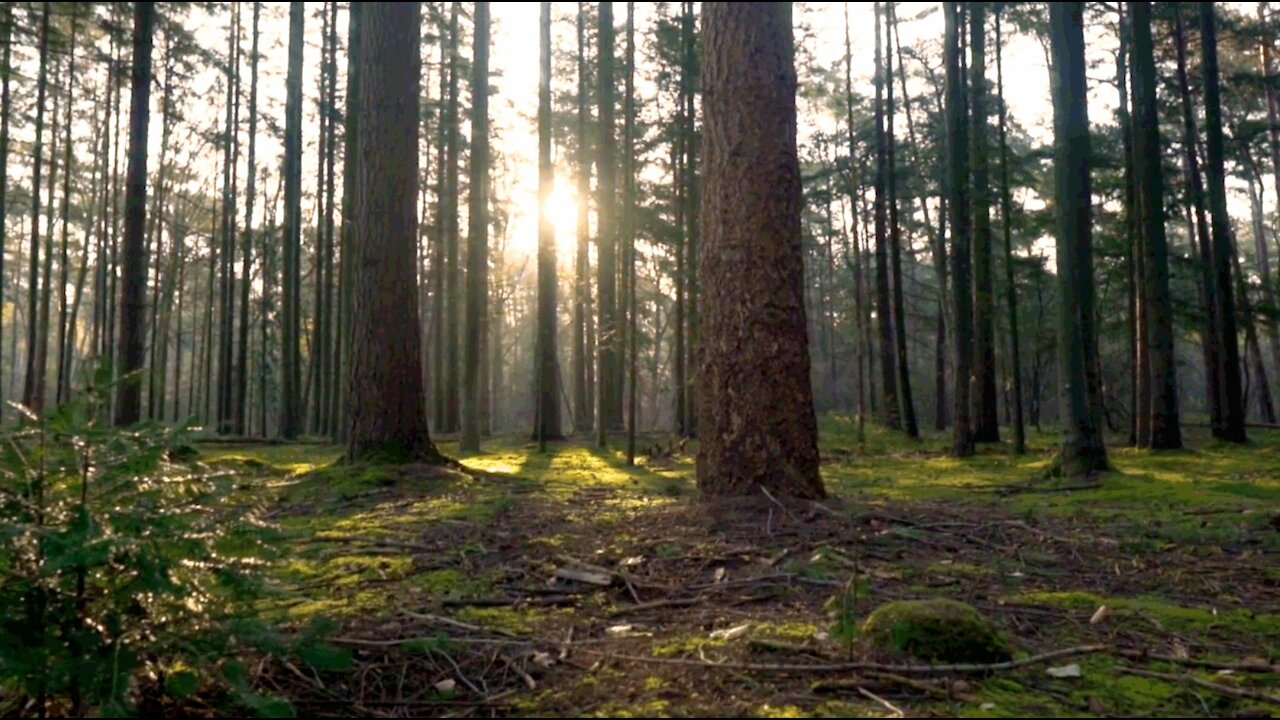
[280,3,303,439]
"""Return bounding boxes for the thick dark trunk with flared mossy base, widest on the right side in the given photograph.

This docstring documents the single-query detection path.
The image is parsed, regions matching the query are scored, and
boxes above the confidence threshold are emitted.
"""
[1048,3,1107,482]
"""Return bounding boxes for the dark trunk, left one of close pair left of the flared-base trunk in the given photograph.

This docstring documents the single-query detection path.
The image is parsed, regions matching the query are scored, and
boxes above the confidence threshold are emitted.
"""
[943,3,974,457]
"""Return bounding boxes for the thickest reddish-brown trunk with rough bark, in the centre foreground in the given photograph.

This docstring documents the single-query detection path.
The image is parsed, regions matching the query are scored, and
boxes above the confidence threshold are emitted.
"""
[698,3,824,498]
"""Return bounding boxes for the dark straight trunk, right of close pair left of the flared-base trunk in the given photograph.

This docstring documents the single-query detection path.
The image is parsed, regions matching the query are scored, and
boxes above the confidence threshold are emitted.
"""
[961,3,1000,442]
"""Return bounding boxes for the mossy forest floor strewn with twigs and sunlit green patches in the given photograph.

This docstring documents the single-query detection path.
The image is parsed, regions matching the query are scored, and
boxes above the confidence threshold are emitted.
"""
[202,418,1280,717]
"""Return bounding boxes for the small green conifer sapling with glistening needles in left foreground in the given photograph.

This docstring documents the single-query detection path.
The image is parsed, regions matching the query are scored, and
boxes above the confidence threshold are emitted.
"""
[0,368,292,716]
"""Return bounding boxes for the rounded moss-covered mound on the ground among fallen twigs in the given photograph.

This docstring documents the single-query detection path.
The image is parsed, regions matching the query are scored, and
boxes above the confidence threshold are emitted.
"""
[863,600,1012,662]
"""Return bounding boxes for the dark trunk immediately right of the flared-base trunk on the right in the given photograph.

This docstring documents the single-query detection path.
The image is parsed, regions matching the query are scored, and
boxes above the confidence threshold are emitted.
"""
[1129,3,1183,450]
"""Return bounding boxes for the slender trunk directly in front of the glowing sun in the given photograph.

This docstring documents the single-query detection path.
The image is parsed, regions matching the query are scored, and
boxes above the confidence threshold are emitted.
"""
[534,3,561,443]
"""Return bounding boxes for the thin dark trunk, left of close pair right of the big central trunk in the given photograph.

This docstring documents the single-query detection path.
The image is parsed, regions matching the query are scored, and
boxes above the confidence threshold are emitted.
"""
[874,3,902,429]
